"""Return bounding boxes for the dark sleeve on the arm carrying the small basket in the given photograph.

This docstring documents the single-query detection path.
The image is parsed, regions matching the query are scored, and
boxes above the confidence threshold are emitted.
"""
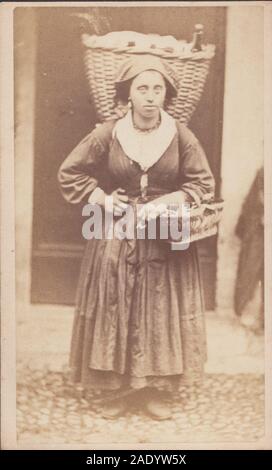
[179,125,215,205]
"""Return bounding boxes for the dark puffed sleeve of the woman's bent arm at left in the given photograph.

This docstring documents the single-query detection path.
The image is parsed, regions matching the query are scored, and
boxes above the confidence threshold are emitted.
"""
[58,123,115,204]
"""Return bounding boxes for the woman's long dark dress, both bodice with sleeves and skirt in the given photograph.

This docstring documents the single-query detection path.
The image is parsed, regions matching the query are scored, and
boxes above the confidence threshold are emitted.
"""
[58,114,214,391]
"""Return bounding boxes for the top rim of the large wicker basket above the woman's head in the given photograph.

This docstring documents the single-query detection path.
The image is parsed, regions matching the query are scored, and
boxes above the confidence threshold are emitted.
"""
[81,33,215,60]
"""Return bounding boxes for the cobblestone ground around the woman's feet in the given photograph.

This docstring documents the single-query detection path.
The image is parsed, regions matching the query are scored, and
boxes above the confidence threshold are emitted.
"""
[17,368,264,445]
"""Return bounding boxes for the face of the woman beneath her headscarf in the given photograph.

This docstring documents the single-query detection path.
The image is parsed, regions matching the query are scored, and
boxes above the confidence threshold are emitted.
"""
[130,70,166,118]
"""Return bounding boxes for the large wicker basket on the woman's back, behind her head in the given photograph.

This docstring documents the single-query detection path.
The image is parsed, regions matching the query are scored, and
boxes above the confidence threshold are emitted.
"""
[82,32,215,124]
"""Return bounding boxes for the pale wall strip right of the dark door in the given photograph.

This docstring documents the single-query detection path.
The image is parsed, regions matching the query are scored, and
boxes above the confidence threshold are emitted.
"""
[216,6,264,310]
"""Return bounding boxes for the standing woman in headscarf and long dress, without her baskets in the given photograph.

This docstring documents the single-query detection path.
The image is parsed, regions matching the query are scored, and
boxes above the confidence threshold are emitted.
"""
[58,55,214,419]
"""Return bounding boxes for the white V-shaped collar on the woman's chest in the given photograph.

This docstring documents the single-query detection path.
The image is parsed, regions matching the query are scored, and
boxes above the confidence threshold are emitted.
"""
[112,109,177,171]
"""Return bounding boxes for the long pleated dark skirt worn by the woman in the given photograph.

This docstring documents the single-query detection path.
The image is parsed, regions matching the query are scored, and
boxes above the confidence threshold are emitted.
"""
[70,225,206,391]
